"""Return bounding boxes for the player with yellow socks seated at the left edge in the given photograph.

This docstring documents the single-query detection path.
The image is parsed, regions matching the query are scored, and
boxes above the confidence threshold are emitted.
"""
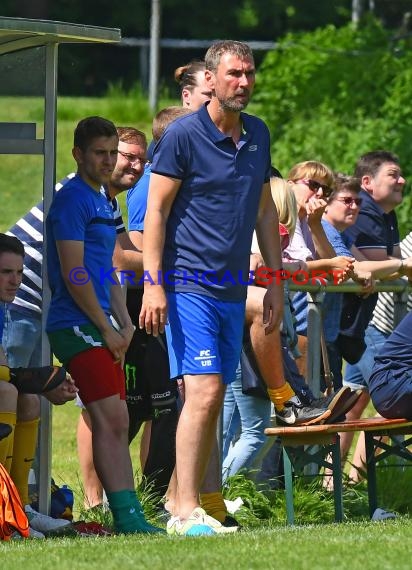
[0,234,77,538]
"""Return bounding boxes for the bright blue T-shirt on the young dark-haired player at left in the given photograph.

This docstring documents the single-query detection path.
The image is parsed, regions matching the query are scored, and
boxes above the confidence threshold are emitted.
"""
[46,175,116,332]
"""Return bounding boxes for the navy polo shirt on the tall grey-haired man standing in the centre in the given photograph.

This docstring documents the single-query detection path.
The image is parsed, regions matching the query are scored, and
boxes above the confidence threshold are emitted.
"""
[152,104,270,301]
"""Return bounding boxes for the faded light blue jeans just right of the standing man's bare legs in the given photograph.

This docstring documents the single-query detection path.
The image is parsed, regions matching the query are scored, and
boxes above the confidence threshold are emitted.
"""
[222,366,271,482]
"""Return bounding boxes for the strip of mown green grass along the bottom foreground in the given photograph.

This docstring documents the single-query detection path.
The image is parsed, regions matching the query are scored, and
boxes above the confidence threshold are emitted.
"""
[0,519,412,570]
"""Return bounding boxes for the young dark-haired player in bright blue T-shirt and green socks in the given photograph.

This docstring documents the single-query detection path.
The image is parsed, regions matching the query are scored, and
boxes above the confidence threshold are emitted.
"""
[47,117,160,534]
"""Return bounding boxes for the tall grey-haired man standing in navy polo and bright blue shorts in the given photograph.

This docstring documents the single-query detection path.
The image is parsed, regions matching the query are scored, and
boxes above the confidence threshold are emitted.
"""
[140,41,283,535]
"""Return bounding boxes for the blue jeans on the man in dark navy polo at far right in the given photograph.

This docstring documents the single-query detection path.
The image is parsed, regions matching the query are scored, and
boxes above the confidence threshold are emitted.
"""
[343,325,388,390]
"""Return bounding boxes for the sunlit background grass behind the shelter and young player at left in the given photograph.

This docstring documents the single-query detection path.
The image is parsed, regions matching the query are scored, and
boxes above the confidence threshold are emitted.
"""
[0,90,175,232]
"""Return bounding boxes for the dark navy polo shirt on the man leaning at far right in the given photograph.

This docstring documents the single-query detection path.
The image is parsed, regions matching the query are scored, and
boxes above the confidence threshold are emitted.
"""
[340,190,399,338]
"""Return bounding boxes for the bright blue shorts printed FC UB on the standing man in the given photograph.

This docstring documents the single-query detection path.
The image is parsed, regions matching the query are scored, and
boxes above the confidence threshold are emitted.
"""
[166,293,245,384]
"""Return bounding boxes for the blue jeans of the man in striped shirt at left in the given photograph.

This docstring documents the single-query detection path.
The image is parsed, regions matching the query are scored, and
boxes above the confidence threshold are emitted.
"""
[3,308,41,368]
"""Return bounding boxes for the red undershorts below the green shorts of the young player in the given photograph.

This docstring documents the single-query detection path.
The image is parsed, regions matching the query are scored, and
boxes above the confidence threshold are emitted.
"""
[67,347,126,404]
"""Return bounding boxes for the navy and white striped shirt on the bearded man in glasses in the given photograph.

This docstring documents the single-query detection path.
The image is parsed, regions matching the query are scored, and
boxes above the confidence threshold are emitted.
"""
[6,172,126,318]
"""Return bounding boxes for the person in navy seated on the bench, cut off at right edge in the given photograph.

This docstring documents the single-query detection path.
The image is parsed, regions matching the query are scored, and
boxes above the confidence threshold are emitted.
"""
[368,312,412,419]
